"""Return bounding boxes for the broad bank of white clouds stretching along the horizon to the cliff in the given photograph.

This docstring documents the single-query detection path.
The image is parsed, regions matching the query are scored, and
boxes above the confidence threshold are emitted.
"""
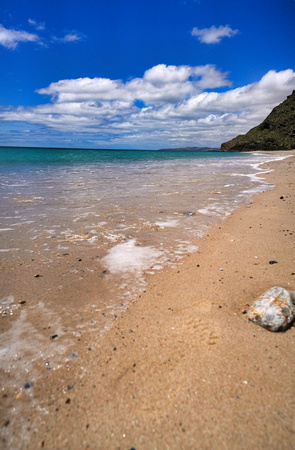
[0,64,295,148]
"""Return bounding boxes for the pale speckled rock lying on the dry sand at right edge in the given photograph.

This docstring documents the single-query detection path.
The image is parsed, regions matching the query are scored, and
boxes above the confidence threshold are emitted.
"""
[248,286,294,331]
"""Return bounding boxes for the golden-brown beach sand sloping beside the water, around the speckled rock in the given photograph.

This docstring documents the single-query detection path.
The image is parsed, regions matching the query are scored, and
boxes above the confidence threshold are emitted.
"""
[1,152,295,450]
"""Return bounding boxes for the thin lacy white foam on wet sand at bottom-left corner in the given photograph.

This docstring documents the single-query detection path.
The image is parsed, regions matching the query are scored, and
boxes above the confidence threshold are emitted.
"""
[0,302,74,448]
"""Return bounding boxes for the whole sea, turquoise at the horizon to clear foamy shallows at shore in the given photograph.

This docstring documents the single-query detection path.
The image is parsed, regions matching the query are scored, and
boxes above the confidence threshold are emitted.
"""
[0,147,288,442]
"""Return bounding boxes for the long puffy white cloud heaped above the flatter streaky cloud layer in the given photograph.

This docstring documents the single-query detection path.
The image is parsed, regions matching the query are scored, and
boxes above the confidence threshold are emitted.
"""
[37,64,231,106]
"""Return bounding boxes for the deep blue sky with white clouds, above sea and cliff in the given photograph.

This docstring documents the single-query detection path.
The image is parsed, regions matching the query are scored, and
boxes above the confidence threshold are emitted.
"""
[0,0,295,149]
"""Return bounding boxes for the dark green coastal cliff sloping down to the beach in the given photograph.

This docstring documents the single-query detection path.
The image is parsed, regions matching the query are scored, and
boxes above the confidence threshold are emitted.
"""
[219,90,295,152]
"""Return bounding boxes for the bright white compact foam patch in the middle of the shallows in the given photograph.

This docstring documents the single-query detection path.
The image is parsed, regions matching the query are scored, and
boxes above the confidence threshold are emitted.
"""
[102,239,163,275]
